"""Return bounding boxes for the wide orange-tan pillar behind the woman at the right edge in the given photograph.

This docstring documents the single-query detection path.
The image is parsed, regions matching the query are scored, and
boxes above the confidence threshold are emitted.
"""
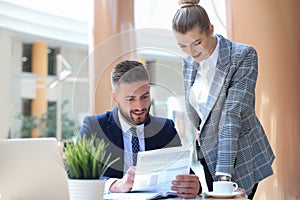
[227,0,300,200]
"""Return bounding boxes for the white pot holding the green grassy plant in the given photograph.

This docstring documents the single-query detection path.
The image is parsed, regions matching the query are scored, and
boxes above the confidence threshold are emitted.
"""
[68,179,105,200]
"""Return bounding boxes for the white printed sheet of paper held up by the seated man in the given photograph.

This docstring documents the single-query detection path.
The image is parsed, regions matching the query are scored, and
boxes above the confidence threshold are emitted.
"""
[132,146,192,192]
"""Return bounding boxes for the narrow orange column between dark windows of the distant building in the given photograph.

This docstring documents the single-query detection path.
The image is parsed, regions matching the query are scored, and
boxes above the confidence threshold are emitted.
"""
[31,42,48,137]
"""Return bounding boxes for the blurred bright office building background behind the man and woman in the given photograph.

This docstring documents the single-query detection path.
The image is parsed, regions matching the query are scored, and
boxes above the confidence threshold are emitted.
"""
[0,0,300,199]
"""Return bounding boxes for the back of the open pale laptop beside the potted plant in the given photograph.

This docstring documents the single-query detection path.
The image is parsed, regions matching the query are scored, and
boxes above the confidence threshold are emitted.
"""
[0,138,69,200]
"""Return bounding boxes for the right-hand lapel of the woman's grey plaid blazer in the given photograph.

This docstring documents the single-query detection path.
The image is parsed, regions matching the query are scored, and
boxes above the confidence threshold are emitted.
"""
[200,35,231,129]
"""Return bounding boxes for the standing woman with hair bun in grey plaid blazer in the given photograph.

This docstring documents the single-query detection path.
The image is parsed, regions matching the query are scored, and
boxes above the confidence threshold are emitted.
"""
[173,0,275,199]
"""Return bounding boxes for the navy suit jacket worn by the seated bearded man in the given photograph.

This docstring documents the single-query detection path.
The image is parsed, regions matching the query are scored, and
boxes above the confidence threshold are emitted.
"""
[79,107,181,178]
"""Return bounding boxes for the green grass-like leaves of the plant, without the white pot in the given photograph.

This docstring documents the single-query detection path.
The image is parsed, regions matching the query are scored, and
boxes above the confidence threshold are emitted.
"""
[65,135,120,179]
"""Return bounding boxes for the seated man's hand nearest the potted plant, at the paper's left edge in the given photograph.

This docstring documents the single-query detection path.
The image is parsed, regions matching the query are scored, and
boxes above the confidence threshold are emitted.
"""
[109,166,136,192]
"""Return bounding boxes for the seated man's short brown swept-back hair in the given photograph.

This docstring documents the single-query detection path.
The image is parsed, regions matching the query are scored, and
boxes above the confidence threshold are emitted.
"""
[111,60,150,90]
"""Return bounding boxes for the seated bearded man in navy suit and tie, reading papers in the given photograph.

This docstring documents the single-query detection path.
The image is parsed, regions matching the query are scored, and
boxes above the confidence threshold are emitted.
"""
[79,61,200,198]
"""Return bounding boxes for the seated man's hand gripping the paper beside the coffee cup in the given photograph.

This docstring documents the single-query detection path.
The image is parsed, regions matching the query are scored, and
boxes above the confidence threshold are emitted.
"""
[171,174,200,198]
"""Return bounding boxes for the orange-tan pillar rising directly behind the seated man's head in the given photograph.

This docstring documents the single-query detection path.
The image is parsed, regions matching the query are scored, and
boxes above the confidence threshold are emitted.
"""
[89,0,135,113]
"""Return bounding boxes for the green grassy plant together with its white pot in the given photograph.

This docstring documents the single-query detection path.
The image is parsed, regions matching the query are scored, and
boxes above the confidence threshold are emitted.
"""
[65,135,119,200]
